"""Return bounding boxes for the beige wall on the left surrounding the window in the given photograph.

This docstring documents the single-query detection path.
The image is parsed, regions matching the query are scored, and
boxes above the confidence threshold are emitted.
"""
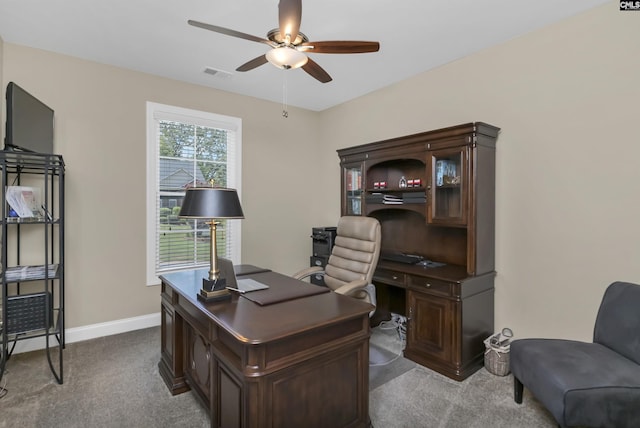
[3,43,328,327]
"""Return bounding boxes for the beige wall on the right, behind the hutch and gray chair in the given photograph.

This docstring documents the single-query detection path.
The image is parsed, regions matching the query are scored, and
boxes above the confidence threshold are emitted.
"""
[321,2,640,340]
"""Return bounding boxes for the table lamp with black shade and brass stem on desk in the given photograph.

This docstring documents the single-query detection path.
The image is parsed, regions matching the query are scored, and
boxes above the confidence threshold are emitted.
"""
[178,187,244,302]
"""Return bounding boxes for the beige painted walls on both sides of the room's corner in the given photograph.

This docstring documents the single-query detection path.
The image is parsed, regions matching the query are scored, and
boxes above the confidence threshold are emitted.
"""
[0,2,640,340]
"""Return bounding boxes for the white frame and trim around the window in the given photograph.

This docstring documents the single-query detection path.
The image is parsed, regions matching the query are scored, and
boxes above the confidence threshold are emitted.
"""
[146,101,242,286]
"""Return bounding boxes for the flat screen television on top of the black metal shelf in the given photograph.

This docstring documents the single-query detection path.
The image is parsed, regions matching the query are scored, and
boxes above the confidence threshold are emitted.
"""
[4,82,53,154]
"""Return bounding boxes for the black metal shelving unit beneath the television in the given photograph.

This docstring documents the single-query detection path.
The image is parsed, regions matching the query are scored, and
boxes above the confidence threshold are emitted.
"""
[0,150,65,384]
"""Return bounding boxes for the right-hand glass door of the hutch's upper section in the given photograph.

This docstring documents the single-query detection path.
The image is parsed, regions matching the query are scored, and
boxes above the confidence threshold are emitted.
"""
[427,147,468,225]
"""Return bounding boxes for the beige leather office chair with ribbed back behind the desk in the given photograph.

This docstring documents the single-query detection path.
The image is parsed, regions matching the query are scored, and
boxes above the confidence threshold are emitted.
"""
[293,216,381,306]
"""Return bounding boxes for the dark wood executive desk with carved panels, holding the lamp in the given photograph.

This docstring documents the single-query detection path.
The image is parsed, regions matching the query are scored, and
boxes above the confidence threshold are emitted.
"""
[158,265,372,428]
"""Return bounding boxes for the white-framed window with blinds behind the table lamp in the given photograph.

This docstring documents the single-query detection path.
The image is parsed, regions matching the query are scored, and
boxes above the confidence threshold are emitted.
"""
[147,102,242,285]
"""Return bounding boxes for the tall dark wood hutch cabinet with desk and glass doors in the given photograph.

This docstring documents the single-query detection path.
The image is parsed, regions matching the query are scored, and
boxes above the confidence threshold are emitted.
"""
[338,122,499,380]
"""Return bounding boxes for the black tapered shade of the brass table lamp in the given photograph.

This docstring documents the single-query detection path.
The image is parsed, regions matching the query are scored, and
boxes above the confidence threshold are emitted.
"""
[178,187,244,219]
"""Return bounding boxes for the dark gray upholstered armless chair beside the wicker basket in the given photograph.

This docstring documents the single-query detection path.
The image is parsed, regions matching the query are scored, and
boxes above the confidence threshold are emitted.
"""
[510,282,640,428]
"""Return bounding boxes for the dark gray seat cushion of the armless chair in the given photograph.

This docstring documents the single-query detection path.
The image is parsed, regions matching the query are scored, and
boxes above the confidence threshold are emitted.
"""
[510,339,640,427]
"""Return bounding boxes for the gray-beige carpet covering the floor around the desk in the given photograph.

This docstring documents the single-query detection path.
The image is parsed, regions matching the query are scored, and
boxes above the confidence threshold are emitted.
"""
[0,327,556,428]
